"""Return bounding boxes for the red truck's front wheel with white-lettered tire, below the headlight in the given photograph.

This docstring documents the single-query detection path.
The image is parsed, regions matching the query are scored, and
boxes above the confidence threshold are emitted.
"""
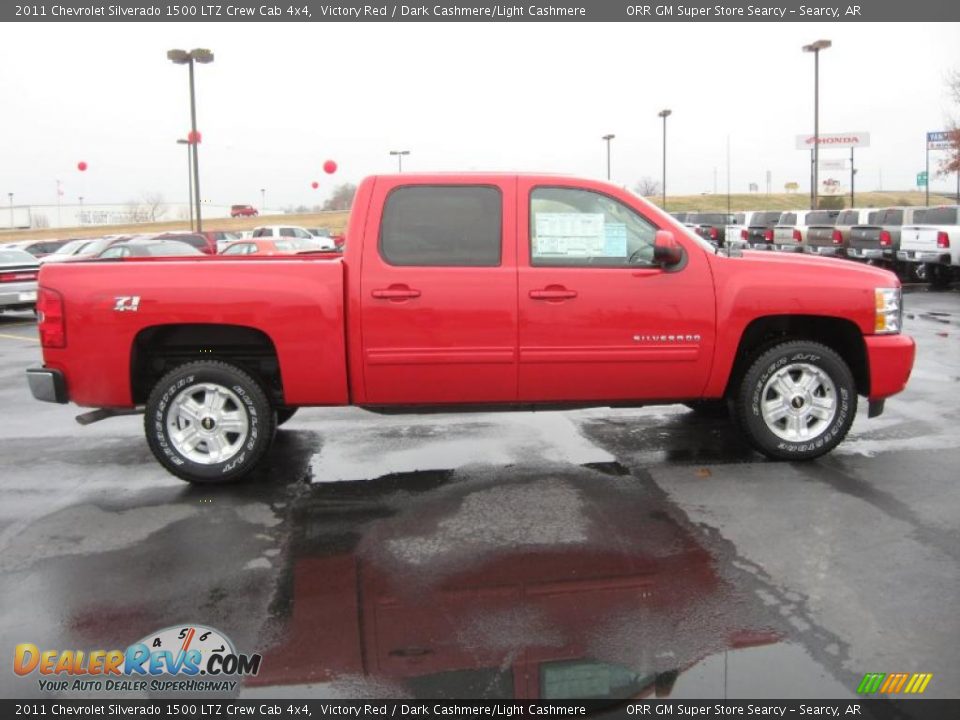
[736,341,857,460]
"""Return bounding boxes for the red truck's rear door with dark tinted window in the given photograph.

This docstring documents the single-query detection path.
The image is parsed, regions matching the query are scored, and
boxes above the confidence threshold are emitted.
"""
[360,176,517,405]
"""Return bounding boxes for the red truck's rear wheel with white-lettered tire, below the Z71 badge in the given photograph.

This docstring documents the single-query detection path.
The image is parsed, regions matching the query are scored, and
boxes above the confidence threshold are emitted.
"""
[143,361,275,483]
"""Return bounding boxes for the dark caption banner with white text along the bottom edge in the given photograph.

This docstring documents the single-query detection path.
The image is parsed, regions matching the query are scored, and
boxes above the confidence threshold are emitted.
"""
[0,698,960,720]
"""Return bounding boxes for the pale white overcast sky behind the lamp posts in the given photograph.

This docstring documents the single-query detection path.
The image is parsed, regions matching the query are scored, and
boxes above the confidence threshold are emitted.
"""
[0,23,960,207]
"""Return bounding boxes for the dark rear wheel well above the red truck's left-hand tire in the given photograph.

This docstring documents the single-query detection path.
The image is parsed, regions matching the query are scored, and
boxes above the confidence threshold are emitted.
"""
[130,323,284,406]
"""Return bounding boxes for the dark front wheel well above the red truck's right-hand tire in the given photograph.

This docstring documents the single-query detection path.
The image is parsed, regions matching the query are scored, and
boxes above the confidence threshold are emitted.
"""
[724,315,870,396]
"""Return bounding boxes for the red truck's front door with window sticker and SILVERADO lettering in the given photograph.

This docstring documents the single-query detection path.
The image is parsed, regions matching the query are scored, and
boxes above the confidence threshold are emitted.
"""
[517,178,716,402]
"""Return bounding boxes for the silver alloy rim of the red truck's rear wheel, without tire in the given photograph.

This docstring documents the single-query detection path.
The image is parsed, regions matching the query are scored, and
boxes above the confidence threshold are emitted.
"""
[167,383,249,465]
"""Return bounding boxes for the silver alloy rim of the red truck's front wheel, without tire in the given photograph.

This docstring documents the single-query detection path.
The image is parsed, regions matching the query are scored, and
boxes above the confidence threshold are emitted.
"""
[760,363,837,442]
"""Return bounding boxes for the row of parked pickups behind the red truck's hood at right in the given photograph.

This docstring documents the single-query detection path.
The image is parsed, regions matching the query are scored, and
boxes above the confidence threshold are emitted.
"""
[673,205,960,286]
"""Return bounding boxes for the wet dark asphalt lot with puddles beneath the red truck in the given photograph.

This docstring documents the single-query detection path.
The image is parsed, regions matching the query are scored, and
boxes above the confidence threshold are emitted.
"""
[0,290,960,699]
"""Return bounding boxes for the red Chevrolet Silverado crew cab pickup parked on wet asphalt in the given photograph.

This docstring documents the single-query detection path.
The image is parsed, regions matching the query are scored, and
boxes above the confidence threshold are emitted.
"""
[27,174,914,482]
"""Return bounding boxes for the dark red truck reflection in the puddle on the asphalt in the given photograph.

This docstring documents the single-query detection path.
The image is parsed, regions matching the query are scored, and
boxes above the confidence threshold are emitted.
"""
[247,468,779,699]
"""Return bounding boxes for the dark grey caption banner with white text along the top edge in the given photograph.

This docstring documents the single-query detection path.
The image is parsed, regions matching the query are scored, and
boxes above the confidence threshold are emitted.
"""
[0,0,960,23]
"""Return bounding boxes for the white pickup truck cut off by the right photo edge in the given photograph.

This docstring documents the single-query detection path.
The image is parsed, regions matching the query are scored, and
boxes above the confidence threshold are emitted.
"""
[897,205,960,287]
